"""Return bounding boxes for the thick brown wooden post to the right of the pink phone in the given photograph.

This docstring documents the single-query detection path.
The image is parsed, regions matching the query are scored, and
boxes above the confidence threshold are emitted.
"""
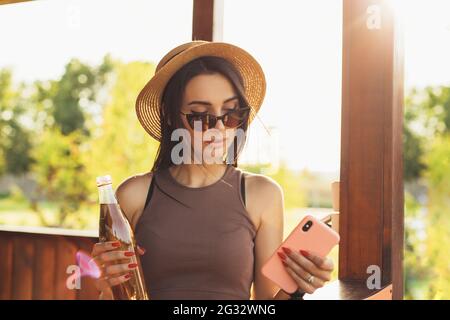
[339,0,404,299]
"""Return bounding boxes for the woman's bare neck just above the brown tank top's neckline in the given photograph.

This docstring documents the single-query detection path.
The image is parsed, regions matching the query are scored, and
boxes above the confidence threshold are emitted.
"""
[169,164,227,188]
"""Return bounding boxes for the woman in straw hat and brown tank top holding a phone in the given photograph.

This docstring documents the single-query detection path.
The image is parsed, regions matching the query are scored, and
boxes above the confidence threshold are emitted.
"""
[92,41,333,299]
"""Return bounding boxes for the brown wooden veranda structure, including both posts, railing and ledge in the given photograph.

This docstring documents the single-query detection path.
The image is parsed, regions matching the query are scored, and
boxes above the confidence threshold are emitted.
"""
[0,0,404,299]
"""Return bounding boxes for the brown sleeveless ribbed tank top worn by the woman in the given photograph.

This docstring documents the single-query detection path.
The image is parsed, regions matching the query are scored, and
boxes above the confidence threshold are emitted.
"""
[135,165,256,300]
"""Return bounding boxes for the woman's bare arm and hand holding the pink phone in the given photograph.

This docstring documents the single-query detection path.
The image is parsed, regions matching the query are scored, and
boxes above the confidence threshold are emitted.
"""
[246,175,334,300]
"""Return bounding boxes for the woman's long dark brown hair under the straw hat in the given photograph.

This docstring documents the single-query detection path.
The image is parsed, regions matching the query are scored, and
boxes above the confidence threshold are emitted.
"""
[152,56,249,172]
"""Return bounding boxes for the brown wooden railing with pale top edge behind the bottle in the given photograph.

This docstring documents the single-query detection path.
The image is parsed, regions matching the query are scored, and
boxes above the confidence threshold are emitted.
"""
[0,226,98,300]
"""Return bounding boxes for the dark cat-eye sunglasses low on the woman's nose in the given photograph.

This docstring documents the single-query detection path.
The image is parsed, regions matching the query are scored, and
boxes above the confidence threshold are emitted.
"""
[180,107,251,131]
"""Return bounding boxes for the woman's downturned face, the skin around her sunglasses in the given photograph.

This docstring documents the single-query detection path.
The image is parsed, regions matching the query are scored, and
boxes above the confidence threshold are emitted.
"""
[181,73,243,159]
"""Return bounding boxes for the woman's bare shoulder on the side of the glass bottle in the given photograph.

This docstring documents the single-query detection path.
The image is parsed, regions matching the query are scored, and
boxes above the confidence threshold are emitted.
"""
[116,172,153,223]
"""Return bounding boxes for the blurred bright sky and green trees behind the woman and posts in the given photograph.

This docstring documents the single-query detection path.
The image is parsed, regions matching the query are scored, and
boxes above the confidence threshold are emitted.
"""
[0,0,450,299]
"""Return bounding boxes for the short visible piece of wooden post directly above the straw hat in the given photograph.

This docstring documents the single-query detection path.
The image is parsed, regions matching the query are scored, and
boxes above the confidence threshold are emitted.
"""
[192,0,224,41]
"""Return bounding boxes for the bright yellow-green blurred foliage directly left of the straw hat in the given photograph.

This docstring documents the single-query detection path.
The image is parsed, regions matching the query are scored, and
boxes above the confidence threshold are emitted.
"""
[85,58,158,196]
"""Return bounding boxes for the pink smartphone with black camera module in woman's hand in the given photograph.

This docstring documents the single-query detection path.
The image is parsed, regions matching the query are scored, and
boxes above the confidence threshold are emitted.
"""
[261,215,340,293]
